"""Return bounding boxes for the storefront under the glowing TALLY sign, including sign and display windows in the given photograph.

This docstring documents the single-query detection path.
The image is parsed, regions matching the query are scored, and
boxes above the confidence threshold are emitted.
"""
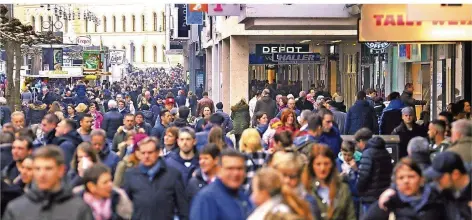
[359,5,472,117]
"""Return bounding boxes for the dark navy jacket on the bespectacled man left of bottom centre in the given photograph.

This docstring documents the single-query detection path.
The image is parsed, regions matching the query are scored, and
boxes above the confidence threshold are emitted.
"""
[123,158,189,220]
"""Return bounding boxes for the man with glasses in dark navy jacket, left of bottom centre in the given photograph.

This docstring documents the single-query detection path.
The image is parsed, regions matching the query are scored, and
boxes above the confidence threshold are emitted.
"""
[123,137,189,220]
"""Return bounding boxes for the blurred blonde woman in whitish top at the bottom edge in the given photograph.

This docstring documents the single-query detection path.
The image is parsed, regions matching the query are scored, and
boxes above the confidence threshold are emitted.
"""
[248,168,313,220]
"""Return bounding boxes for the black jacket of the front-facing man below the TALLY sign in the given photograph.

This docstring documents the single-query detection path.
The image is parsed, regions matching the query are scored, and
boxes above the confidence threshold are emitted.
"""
[392,122,428,158]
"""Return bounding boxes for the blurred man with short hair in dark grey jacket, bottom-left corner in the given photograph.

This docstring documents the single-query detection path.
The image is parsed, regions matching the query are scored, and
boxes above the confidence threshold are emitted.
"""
[2,145,94,220]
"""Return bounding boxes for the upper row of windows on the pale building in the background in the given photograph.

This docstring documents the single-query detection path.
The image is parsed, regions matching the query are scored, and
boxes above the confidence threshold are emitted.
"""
[31,12,166,33]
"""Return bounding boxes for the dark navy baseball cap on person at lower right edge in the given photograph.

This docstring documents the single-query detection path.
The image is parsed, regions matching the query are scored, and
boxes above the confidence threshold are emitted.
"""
[424,151,467,179]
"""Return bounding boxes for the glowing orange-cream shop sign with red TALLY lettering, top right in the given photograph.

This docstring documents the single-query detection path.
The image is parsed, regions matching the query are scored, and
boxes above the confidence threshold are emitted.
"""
[358,4,472,42]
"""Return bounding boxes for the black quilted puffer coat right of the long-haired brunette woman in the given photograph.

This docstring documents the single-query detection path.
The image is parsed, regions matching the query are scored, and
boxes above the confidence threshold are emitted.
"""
[356,137,393,203]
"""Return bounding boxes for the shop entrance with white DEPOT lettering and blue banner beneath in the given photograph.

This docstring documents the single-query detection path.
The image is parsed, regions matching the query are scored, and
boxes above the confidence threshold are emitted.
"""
[249,44,327,96]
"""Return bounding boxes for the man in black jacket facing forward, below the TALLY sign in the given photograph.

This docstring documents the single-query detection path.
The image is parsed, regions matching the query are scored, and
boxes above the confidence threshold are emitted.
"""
[392,107,428,158]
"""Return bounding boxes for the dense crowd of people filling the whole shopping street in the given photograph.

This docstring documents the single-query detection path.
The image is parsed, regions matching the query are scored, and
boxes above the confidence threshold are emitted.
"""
[0,69,472,220]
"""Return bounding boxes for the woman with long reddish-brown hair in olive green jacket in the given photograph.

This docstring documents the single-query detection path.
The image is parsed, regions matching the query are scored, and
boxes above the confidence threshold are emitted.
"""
[302,144,356,220]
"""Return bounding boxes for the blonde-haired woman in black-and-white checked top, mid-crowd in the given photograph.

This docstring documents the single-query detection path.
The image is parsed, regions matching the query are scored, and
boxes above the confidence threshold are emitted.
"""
[239,128,268,190]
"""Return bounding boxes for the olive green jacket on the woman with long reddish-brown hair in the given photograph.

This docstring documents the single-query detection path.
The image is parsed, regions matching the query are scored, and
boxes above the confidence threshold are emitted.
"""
[312,181,356,220]
